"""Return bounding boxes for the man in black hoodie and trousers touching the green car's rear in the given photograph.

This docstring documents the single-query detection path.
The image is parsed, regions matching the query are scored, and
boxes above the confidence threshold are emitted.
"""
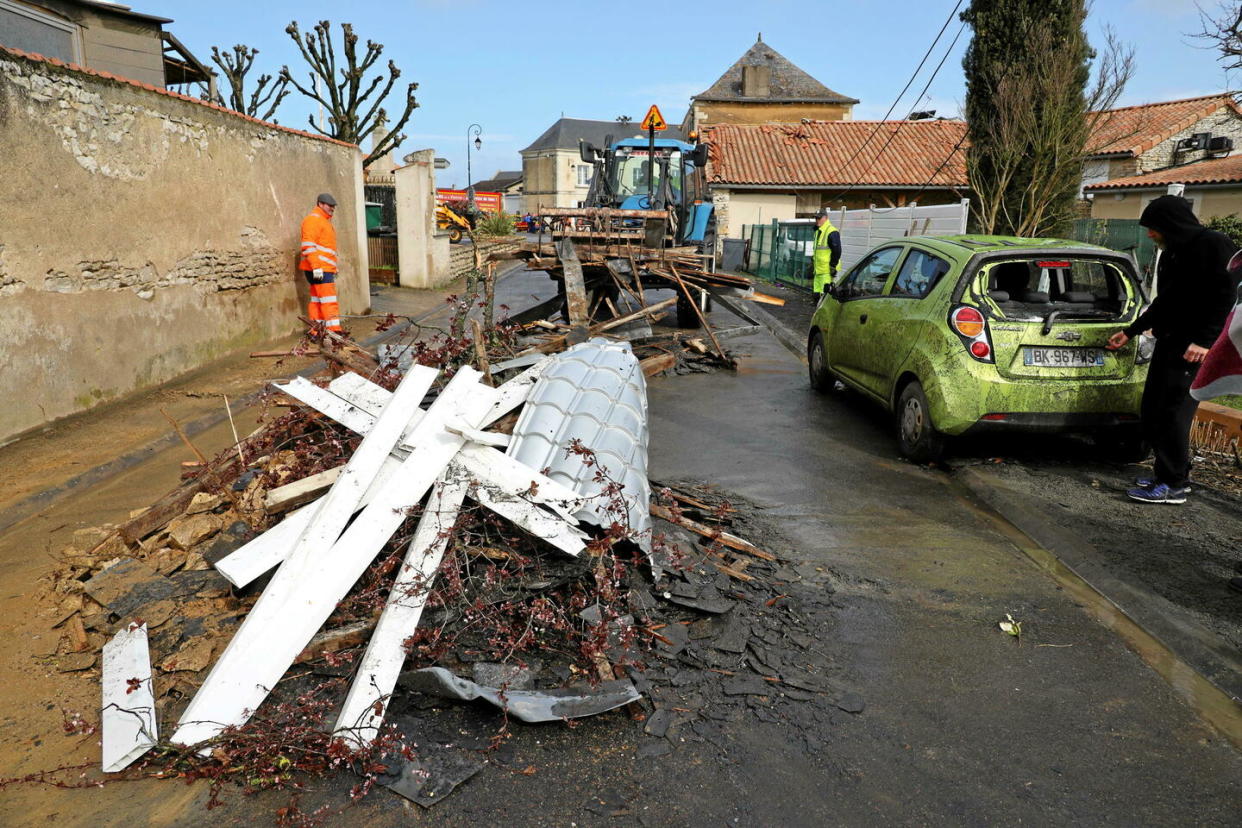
[1108,195,1237,503]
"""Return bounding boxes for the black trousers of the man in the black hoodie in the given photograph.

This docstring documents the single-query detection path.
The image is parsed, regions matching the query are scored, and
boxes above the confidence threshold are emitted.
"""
[1143,341,1199,489]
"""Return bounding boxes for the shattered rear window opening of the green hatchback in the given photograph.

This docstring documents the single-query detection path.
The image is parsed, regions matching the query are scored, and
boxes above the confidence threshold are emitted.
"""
[975,256,1136,318]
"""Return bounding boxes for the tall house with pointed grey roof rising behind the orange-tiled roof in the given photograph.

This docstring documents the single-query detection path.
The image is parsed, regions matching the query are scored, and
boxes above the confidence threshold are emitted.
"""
[682,35,858,133]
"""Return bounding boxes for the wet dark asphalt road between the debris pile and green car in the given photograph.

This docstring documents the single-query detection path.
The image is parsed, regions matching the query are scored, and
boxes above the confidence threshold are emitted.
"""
[2,275,1242,826]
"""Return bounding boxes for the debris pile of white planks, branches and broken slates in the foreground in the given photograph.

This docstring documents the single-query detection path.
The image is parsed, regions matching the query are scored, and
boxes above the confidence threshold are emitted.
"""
[29,327,840,804]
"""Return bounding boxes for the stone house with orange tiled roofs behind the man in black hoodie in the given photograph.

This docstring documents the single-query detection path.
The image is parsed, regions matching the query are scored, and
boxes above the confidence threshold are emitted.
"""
[1083,94,1242,218]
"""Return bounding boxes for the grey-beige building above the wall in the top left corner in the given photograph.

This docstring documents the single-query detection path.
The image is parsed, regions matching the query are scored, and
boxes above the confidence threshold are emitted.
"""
[0,0,216,99]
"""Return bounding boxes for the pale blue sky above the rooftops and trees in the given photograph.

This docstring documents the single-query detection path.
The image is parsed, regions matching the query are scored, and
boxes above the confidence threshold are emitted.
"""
[162,0,1237,186]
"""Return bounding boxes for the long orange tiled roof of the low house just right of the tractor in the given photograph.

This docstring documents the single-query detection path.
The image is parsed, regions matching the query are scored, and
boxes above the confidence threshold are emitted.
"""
[703,120,968,189]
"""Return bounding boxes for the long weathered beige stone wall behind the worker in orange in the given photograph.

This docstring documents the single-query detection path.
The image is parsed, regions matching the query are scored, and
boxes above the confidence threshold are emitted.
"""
[0,48,370,441]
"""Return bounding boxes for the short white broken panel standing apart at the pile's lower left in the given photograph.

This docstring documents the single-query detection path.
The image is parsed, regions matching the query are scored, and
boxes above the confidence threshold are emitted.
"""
[101,624,159,773]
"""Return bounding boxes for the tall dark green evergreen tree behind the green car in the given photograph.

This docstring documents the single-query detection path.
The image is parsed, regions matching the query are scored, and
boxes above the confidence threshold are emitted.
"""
[963,0,1134,236]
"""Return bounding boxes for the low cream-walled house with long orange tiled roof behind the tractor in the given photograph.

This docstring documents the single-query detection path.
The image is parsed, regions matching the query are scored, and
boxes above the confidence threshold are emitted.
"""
[703,120,968,243]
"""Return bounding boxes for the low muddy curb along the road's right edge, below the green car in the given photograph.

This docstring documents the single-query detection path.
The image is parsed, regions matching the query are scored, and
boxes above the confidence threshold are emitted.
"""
[951,467,1242,749]
